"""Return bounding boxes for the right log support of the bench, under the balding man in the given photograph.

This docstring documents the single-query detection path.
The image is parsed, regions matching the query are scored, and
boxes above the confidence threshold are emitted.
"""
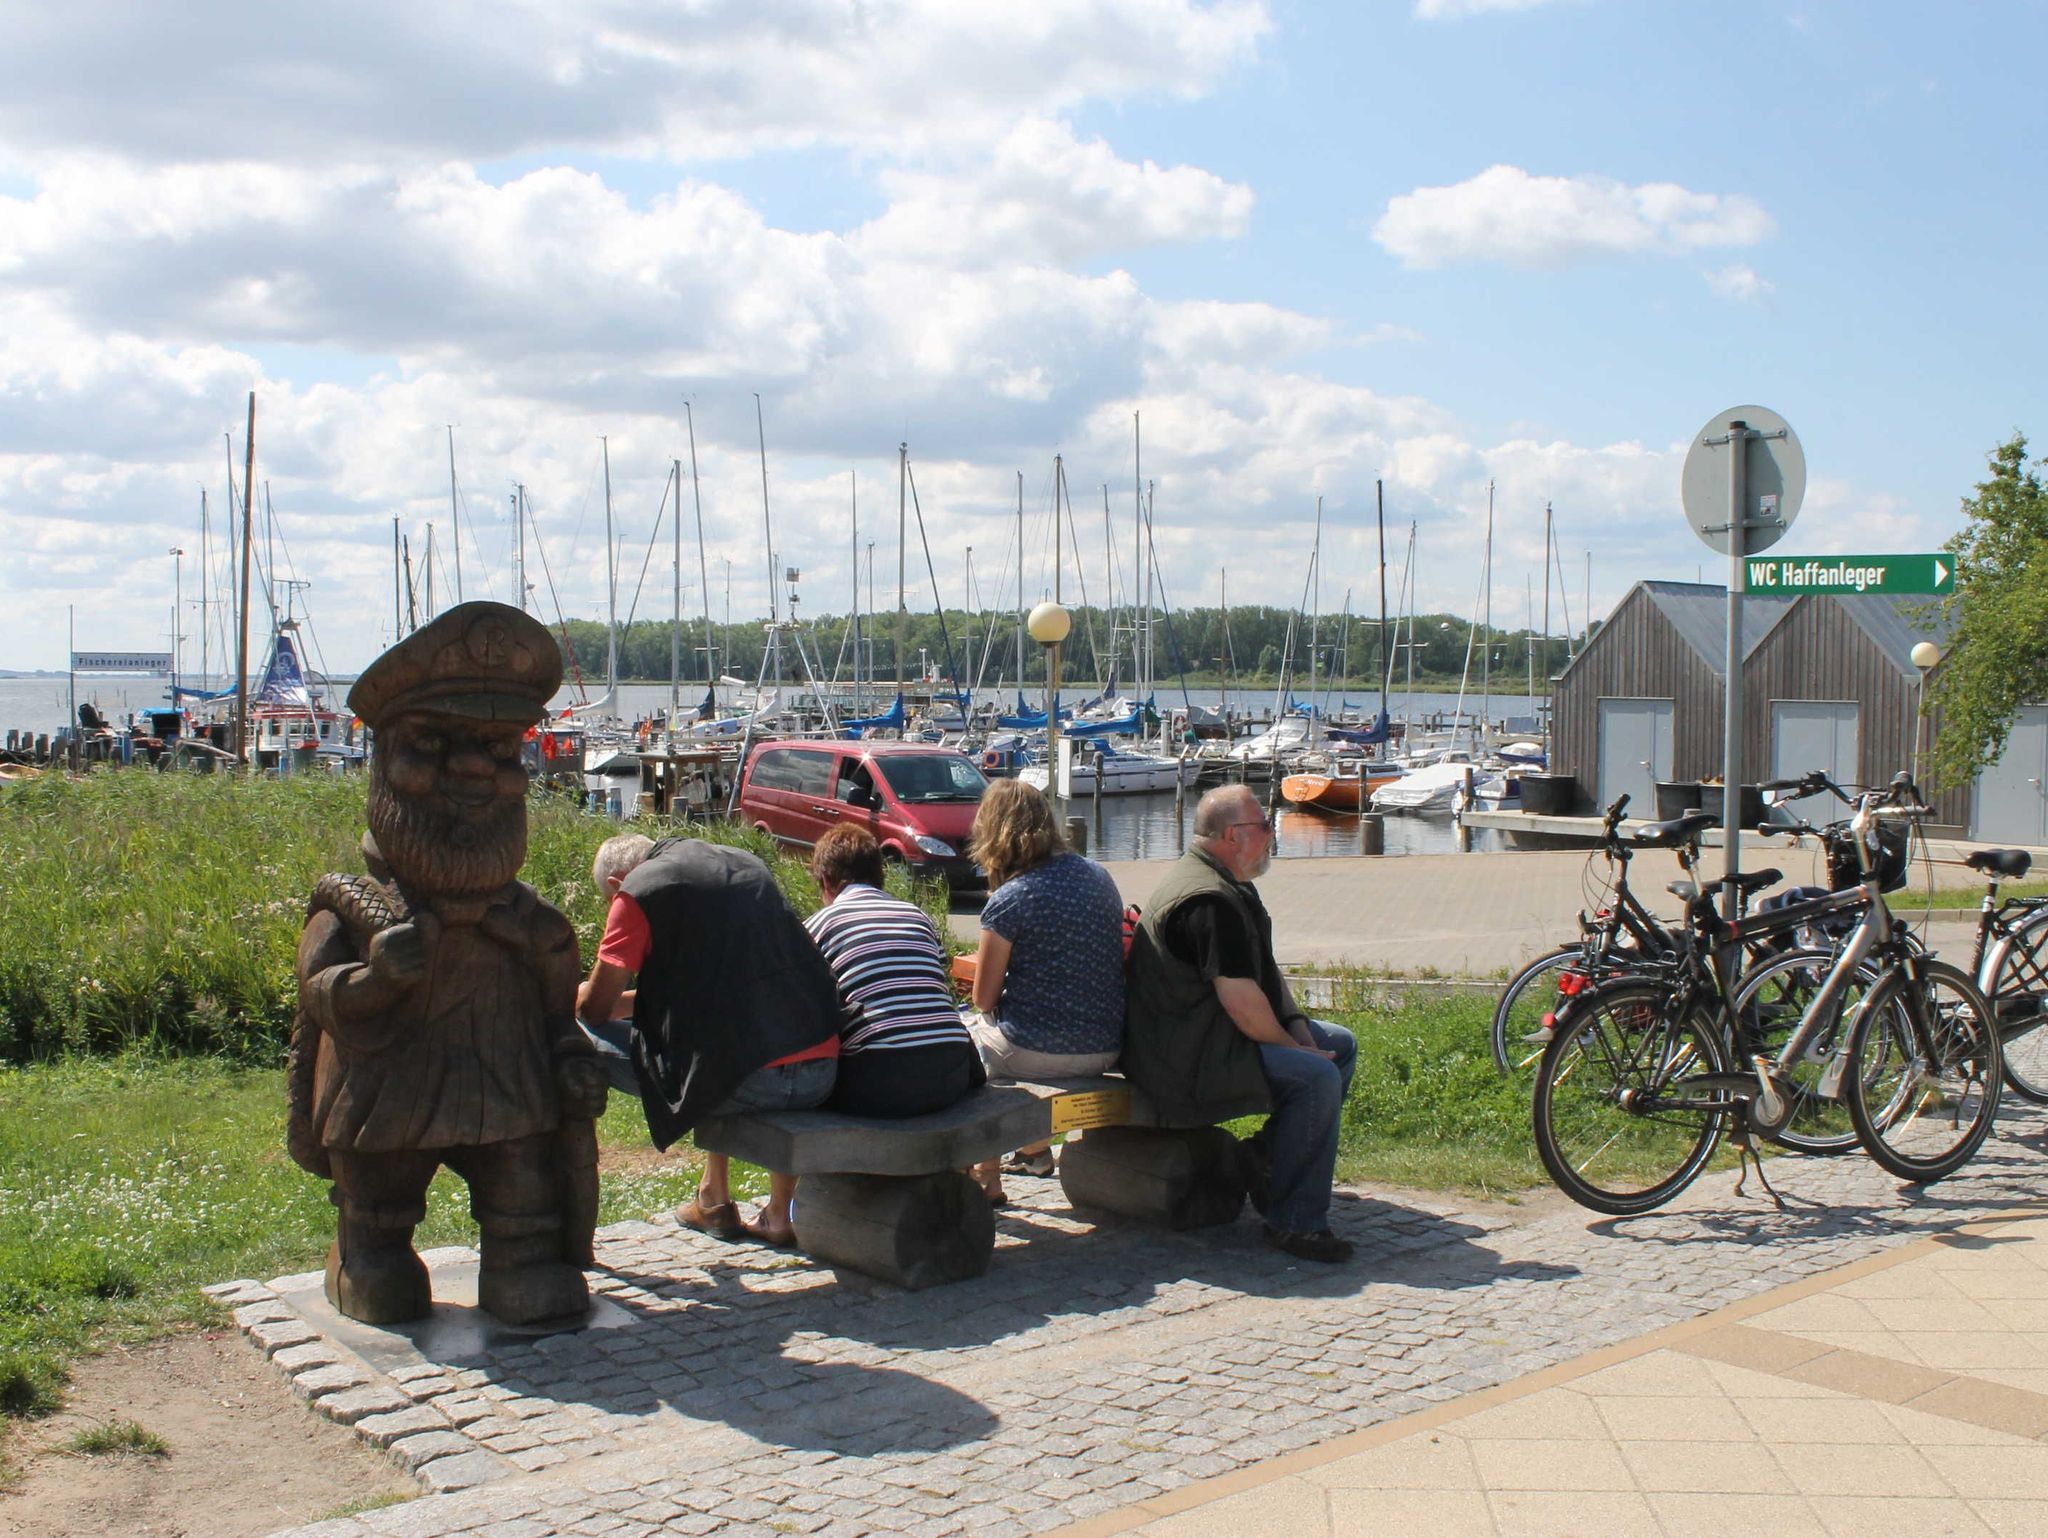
[1059,1126,1245,1229]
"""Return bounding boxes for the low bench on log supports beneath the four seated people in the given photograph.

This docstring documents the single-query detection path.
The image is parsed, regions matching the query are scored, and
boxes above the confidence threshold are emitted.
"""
[694,1075,1264,1288]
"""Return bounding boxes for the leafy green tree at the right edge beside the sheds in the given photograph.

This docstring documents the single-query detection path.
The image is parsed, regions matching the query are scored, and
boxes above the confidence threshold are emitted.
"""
[1931,432,2048,784]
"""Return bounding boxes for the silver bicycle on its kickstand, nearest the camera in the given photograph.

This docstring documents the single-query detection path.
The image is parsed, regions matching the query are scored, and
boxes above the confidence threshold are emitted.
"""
[1530,774,2001,1216]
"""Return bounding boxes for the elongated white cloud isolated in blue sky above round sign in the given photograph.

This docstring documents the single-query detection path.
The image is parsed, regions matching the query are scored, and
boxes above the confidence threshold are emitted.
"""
[1372,166,1774,268]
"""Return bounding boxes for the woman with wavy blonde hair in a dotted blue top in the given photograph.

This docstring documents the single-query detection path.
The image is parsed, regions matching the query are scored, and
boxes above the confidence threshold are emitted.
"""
[969,780,1124,1202]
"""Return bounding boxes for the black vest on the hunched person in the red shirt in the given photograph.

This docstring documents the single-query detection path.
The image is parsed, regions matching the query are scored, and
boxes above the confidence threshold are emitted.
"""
[621,838,844,1149]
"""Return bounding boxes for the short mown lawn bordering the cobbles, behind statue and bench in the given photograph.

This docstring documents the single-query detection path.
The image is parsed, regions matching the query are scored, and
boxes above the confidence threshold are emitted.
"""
[0,997,1542,1449]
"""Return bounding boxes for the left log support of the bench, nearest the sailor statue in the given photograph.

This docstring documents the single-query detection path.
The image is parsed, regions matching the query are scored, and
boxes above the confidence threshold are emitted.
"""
[791,1169,995,1290]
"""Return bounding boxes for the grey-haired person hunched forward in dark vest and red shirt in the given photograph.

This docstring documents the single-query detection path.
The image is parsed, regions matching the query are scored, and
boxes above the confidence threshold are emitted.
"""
[575,834,840,1245]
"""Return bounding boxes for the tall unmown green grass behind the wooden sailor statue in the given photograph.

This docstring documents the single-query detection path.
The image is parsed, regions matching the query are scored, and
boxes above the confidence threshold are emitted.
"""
[0,770,944,1065]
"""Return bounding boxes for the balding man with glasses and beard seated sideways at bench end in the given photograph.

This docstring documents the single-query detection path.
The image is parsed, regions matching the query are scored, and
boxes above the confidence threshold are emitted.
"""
[1122,784,1358,1262]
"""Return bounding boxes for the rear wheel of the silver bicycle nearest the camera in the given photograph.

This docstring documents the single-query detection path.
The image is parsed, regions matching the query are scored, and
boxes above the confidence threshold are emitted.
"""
[1530,981,1735,1216]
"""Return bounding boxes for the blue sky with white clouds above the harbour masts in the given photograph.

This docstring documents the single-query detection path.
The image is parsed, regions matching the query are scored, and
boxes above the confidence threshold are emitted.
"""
[0,0,2048,672]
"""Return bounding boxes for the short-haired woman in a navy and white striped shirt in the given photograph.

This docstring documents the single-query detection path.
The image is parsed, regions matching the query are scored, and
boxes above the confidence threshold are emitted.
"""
[805,823,987,1116]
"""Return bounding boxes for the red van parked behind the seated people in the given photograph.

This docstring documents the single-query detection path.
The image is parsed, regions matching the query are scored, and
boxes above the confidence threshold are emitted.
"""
[737,739,989,889]
